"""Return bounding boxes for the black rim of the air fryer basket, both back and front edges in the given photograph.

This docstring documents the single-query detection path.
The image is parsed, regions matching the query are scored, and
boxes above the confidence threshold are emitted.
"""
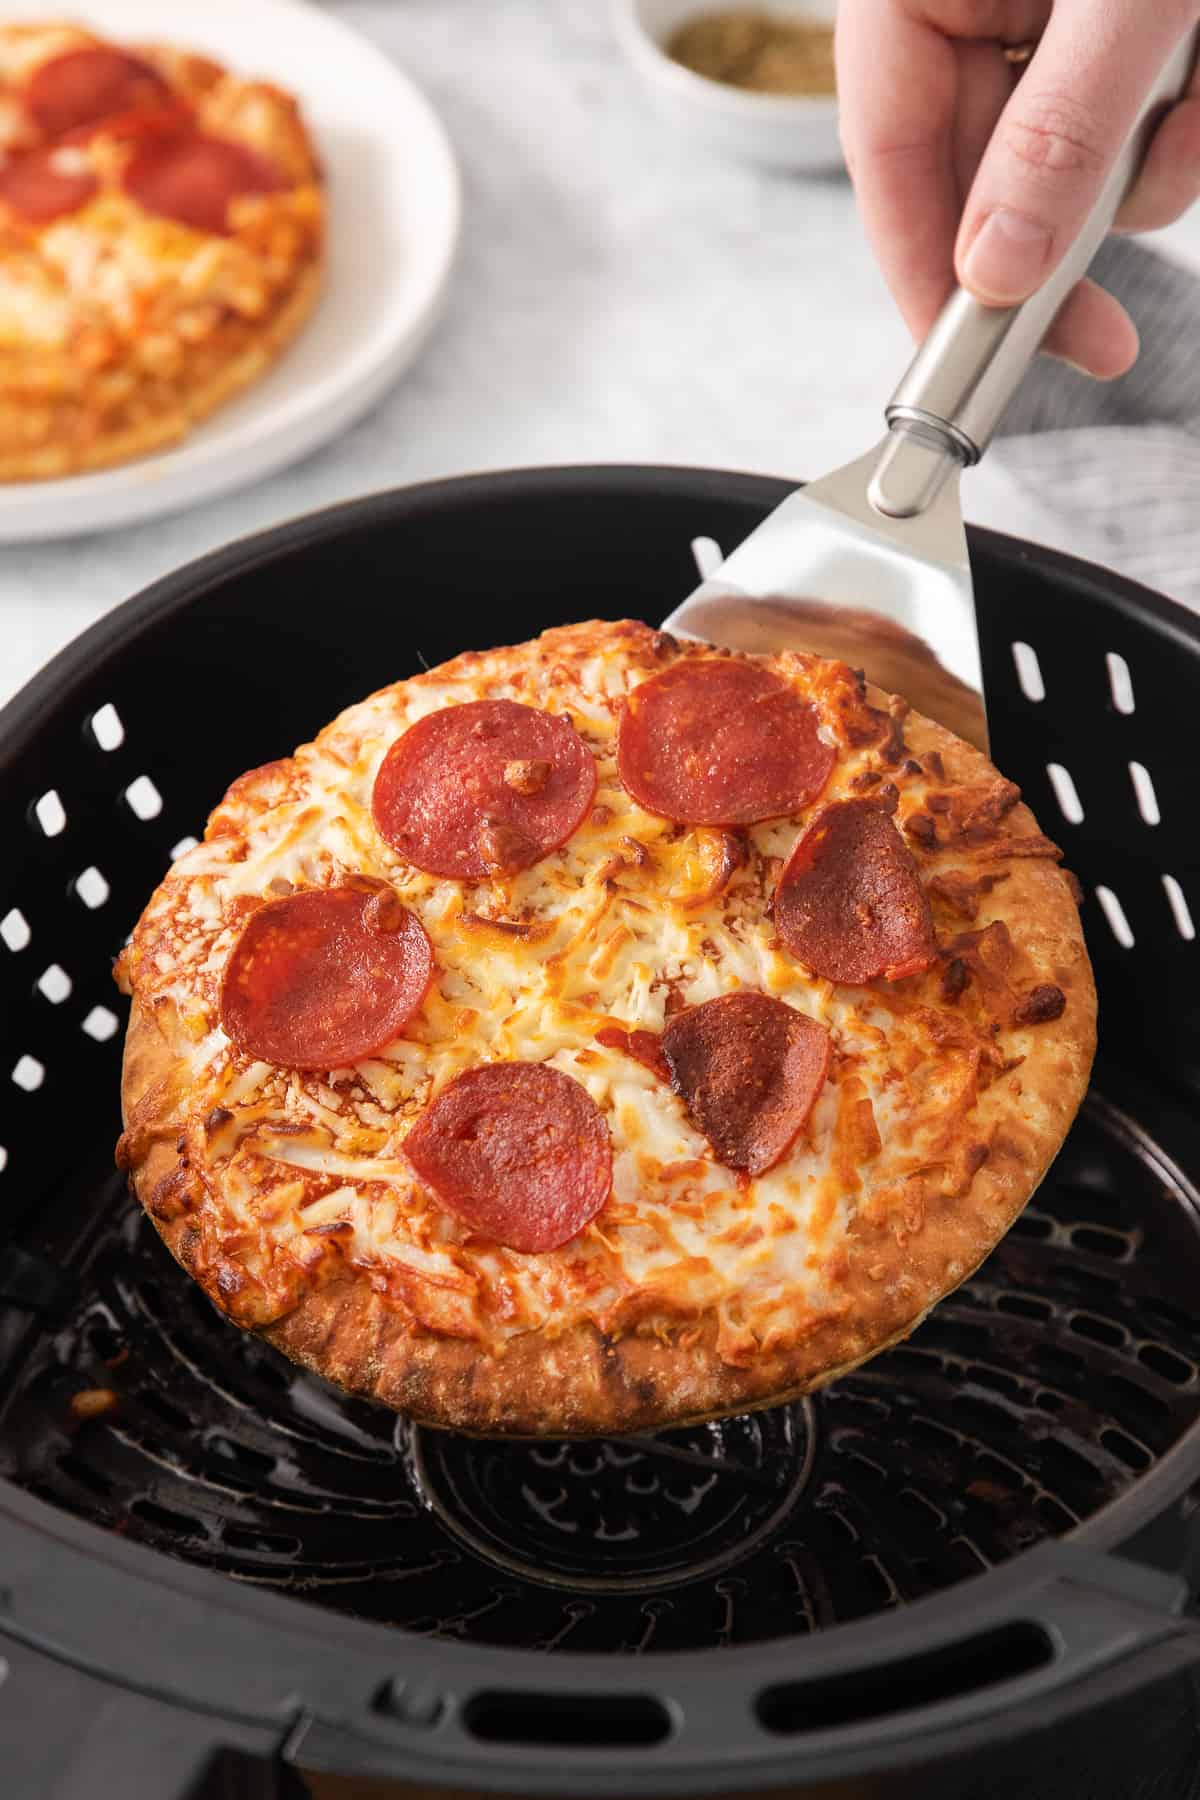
[0,464,1200,1793]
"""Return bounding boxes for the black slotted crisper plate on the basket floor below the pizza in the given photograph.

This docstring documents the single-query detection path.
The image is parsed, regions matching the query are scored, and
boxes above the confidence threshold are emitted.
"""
[0,1100,1200,1652]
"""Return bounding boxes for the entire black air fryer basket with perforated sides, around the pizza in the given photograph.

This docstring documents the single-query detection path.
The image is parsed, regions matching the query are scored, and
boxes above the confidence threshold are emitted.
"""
[0,470,1200,1800]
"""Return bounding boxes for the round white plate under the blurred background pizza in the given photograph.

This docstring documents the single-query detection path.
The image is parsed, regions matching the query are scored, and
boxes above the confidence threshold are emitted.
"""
[0,0,461,544]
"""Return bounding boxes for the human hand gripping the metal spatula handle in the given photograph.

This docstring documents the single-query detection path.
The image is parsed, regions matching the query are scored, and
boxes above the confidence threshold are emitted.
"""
[837,0,1200,380]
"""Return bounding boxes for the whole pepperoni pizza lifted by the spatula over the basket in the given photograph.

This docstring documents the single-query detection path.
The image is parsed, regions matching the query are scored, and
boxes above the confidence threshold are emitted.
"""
[117,623,1096,1435]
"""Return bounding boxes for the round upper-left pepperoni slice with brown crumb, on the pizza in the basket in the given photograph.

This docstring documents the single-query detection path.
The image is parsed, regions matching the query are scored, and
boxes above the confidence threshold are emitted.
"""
[372,700,596,880]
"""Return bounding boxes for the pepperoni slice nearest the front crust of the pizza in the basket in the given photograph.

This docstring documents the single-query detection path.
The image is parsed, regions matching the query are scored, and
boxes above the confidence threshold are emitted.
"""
[405,1062,612,1251]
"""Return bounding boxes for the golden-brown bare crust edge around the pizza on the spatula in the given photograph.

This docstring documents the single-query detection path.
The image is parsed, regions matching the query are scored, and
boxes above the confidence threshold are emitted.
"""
[122,626,1096,1436]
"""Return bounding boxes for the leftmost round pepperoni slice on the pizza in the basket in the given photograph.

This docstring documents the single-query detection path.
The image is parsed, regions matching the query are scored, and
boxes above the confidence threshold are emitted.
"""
[221,887,434,1069]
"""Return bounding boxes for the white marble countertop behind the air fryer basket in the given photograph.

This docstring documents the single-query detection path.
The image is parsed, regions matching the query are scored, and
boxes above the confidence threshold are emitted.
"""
[0,0,1200,702]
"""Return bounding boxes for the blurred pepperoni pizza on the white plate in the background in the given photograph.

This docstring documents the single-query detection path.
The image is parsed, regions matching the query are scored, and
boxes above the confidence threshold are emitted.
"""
[0,23,324,481]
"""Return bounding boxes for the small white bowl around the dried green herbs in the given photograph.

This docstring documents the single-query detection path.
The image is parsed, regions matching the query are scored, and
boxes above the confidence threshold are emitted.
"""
[612,0,844,175]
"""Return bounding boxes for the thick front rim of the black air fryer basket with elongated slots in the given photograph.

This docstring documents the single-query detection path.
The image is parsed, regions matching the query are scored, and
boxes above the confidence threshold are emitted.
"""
[0,1483,1200,1800]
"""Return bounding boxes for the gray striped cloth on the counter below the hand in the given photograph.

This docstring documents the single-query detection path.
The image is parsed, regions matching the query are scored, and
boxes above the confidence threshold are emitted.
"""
[963,238,1200,610]
